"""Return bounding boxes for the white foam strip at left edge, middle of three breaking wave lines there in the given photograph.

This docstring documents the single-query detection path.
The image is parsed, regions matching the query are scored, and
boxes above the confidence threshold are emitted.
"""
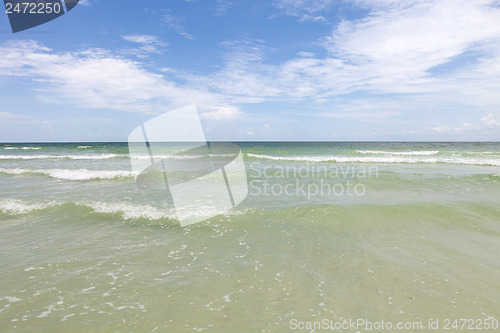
[0,168,136,181]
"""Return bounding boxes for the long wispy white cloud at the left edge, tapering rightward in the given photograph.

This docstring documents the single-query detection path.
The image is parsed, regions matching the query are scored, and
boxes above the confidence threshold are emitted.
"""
[0,41,221,113]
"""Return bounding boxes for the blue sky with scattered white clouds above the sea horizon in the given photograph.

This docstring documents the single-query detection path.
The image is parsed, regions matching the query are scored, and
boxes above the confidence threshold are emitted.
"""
[0,0,500,142]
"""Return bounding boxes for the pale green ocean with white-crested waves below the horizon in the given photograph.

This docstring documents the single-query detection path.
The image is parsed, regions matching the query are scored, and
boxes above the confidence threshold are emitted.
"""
[0,142,500,332]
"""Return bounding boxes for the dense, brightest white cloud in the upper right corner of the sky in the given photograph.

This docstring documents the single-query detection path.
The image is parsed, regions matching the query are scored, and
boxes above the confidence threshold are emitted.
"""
[326,0,500,72]
